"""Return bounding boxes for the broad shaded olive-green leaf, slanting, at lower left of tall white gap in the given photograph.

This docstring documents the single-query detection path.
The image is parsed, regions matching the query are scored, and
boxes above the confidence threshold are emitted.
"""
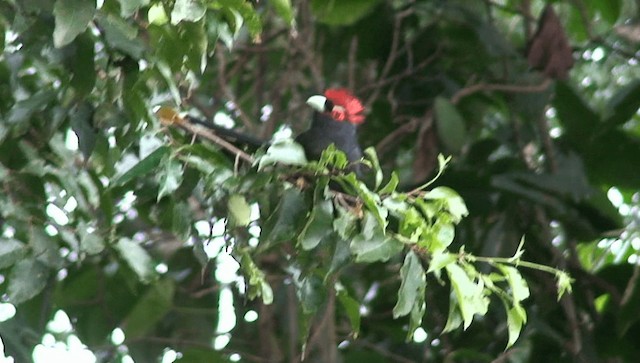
[124,278,176,339]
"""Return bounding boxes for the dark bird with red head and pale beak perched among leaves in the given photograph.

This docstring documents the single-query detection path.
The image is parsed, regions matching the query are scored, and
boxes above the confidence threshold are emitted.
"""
[295,88,365,170]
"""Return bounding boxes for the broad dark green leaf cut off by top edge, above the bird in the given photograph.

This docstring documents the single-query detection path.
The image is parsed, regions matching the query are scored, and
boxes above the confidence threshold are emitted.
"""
[311,0,379,25]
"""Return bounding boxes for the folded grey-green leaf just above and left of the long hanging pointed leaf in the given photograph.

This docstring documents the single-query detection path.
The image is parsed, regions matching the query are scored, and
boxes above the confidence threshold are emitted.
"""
[350,212,404,263]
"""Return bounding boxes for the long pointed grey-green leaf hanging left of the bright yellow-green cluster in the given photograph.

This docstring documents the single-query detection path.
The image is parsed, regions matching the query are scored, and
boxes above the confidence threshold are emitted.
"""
[393,251,427,318]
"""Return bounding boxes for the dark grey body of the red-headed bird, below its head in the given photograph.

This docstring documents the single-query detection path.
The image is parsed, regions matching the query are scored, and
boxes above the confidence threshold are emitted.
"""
[296,112,362,163]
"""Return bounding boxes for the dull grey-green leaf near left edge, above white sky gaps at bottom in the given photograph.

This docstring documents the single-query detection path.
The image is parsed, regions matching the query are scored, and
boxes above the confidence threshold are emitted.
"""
[7,258,49,305]
